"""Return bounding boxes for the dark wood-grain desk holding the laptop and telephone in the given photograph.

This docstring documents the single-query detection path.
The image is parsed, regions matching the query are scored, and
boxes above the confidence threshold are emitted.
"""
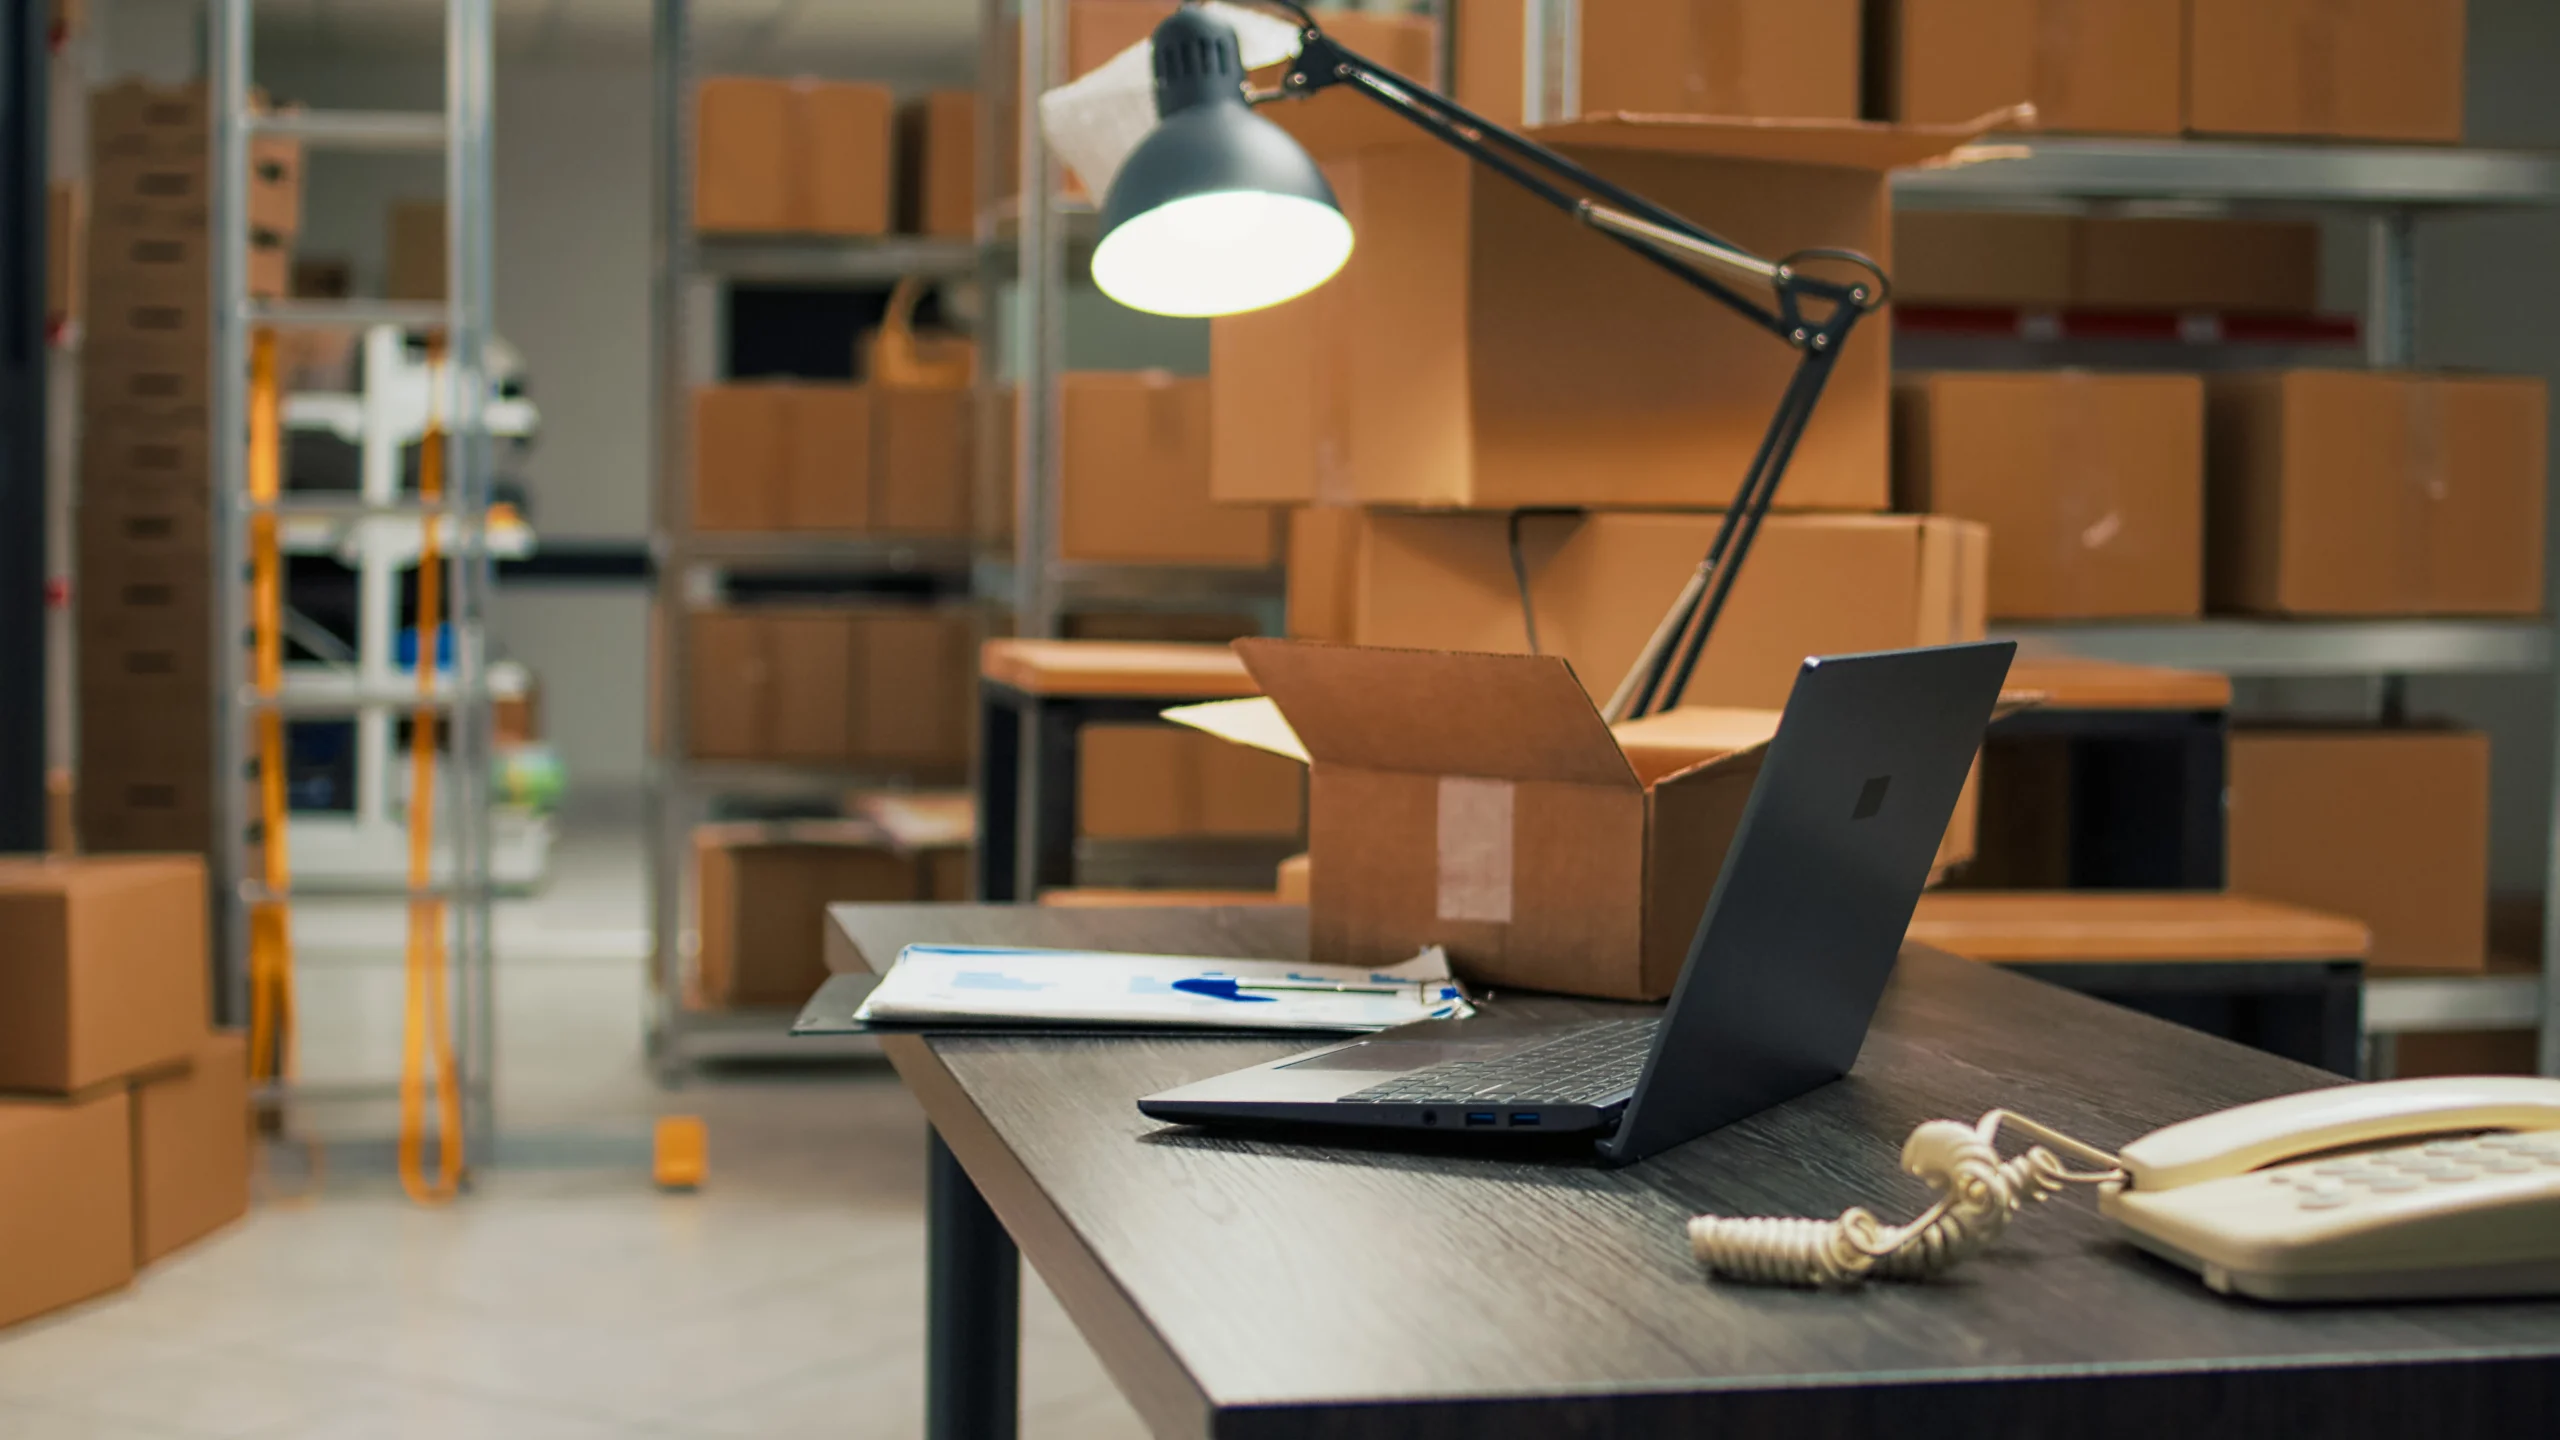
[827,904,2560,1440]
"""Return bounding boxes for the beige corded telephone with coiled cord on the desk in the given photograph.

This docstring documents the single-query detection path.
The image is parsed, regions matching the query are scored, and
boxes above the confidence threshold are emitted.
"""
[1690,1076,2560,1302]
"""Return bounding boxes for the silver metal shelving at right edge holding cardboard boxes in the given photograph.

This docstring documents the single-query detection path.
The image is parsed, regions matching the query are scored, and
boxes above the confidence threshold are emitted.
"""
[1935,136,2560,1074]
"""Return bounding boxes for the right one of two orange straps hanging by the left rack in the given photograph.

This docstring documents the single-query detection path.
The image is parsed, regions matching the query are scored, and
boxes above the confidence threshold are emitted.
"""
[399,338,463,1204]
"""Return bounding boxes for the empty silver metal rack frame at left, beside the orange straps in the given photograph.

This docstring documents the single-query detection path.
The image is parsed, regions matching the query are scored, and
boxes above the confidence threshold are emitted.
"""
[207,0,497,1147]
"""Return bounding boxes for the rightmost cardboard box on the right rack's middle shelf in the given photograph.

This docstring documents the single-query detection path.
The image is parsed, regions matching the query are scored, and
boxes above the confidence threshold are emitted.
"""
[2204,369,2545,615]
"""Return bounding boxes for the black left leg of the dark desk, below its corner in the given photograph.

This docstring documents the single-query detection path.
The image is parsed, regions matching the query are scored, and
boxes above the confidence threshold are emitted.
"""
[924,1133,1021,1440]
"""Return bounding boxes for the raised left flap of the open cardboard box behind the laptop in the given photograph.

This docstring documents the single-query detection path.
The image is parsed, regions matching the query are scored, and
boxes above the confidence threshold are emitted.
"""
[1234,638,1636,789]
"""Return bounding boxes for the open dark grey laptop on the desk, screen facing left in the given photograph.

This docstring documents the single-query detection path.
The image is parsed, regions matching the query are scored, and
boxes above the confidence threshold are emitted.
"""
[1139,641,2017,1163]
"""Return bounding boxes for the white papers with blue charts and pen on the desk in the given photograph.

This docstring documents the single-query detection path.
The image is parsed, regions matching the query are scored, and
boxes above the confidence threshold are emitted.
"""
[855,945,1475,1033]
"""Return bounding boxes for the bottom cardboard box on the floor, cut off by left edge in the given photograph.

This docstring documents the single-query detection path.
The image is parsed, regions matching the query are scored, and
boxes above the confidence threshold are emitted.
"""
[0,1086,133,1325]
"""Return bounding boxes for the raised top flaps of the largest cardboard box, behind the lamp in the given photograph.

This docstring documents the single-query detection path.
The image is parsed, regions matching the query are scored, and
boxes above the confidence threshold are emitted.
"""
[1300,92,2035,172]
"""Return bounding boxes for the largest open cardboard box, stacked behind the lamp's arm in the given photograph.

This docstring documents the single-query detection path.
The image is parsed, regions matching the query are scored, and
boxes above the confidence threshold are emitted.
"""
[1211,116,1971,510]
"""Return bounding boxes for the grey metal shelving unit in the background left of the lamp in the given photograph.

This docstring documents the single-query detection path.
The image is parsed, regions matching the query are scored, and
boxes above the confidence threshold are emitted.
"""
[650,0,1283,1076]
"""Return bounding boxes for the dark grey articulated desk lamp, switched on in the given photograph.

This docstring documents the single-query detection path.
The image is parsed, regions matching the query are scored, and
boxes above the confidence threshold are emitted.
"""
[1093,0,1889,720]
